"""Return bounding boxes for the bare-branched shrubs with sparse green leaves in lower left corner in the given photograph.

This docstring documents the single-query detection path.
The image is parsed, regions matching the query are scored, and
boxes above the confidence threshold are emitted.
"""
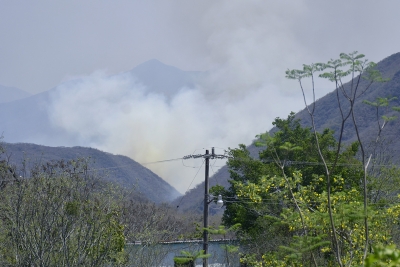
[0,160,126,266]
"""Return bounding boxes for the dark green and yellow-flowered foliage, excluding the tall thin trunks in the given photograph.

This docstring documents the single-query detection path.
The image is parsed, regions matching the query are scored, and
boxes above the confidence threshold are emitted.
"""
[219,114,400,266]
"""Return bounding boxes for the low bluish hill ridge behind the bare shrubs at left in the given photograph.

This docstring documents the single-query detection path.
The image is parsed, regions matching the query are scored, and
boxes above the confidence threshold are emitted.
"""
[3,143,180,203]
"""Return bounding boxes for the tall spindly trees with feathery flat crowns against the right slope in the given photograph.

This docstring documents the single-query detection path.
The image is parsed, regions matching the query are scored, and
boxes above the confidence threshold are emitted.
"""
[286,52,398,266]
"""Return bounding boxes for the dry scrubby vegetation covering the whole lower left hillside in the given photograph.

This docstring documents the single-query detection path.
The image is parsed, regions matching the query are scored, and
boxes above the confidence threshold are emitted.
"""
[0,148,199,267]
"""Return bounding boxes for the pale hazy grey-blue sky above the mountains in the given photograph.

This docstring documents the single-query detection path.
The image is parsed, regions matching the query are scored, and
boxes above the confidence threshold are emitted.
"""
[0,0,400,93]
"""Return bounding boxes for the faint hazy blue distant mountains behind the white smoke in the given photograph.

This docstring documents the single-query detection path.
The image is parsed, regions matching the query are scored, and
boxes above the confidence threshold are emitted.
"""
[0,59,200,146]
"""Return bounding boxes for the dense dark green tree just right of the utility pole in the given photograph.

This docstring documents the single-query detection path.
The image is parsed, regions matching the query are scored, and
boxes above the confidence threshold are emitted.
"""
[218,113,361,266]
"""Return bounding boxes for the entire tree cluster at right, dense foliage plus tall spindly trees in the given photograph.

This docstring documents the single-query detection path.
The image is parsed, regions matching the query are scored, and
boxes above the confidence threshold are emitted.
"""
[213,52,400,267]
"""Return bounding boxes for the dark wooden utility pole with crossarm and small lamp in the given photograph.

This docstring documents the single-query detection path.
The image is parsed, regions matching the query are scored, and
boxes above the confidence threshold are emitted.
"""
[183,148,227,267]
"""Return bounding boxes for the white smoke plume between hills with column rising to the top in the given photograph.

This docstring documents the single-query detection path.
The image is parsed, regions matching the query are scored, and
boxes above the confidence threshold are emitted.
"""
[49,2,316,193]
